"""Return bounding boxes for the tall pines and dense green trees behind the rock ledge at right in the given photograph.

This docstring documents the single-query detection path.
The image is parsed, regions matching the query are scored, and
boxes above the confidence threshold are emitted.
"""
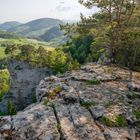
[61,0,140,70]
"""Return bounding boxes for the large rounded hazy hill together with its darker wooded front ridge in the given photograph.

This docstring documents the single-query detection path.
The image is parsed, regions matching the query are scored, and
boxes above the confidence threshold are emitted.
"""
[0,18,65,44]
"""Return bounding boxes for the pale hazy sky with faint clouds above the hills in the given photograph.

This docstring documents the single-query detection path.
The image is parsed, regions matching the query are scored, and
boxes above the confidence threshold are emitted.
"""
[0,0,97,23]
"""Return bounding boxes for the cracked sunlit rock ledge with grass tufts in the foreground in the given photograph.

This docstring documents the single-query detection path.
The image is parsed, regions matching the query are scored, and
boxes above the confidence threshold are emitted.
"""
[0,64,140,140]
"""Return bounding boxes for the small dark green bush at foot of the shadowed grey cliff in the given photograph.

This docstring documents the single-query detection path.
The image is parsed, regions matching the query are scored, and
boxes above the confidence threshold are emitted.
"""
[7,101,17,115]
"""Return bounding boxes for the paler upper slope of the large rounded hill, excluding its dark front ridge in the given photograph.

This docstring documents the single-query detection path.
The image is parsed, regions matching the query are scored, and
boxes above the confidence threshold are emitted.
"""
[8,18,63,38]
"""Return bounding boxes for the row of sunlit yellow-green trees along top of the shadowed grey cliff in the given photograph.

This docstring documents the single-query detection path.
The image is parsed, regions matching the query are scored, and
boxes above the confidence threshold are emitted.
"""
[5,44,80,73]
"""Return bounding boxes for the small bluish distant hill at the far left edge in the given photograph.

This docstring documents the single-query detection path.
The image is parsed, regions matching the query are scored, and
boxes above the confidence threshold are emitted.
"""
[0,21,21,31]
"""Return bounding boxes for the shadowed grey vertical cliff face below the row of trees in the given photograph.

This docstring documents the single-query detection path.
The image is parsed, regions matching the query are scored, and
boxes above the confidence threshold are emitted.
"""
[0,60,50,112]
